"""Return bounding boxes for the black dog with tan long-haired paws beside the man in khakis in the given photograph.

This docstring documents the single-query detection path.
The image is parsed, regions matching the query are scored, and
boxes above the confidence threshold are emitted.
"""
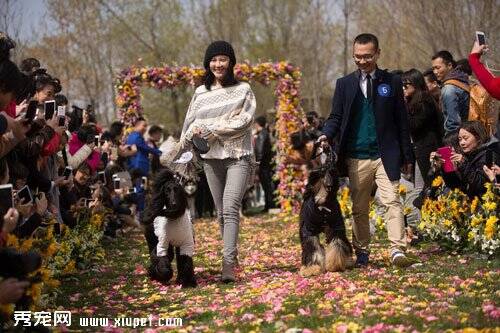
[300,139,353,276]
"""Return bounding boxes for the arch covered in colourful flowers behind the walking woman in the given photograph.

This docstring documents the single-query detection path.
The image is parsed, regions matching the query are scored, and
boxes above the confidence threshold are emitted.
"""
[116,61,306,214]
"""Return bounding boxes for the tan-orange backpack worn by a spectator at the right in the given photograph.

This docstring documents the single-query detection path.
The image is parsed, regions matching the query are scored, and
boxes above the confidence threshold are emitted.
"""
[445,79,498,135]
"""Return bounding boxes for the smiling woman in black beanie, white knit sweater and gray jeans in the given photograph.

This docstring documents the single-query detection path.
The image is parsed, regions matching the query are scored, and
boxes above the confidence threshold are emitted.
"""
[181,41,256,282]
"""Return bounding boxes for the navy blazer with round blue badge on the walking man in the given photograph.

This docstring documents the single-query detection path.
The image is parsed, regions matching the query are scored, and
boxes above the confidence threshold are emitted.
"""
[323,68,414,181]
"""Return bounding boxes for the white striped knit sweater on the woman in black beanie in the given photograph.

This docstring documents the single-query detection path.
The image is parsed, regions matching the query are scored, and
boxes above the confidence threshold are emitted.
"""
[181,82,256,159]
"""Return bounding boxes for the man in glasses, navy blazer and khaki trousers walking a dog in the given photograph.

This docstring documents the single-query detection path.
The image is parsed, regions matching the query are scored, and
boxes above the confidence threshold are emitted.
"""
[320,33,414,267]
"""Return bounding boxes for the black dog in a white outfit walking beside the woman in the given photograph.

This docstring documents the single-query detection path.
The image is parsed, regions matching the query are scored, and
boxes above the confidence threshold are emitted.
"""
[142,168,196,288]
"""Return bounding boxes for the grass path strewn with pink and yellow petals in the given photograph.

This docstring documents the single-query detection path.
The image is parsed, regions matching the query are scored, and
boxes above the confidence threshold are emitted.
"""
[49,215,500,332]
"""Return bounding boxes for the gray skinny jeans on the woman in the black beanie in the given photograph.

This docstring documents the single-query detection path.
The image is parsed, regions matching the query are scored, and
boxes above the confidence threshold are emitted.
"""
[203,156,253,264]
